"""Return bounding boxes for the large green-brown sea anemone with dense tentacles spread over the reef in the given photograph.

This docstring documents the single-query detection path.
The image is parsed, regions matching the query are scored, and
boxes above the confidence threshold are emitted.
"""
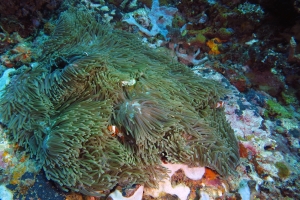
[1,10,239,196]
